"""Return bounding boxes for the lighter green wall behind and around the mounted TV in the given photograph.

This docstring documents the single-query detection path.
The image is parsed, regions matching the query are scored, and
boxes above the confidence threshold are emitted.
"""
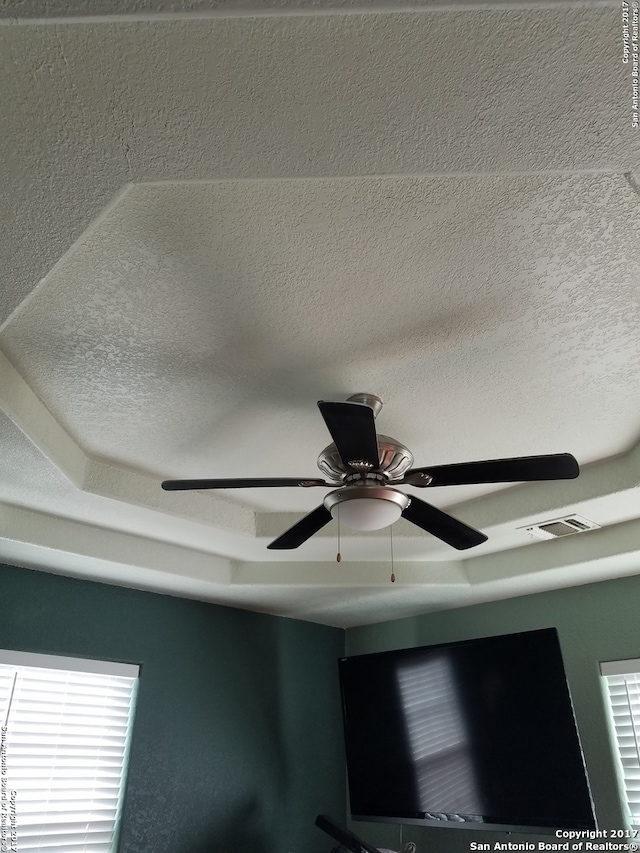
[346,577,640,853]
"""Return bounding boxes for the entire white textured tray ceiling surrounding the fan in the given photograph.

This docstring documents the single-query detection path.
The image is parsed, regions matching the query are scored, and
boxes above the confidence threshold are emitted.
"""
[0,0,640,626]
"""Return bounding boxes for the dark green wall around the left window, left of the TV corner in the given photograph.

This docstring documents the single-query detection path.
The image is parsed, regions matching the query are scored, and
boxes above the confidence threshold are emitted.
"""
[0,566,346,853]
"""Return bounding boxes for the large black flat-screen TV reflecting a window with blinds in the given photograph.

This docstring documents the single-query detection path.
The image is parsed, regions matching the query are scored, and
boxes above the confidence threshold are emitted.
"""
[339,628,596,832]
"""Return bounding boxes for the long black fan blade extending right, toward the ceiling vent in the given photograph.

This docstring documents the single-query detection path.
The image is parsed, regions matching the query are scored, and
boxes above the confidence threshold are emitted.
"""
[402,453,580,486]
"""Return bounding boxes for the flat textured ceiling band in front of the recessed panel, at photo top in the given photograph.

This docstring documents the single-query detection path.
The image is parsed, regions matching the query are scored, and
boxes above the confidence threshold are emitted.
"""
[0,8,640,319]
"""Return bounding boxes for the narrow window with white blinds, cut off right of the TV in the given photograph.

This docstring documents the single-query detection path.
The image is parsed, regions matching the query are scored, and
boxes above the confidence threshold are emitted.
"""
[600,659,640,828]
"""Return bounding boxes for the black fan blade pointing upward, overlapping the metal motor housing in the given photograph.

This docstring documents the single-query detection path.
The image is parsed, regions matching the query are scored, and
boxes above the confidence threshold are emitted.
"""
[318,400,380,471]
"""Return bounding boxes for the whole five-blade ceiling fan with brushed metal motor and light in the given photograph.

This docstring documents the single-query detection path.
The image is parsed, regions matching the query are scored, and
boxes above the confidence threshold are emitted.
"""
[162,394,580,551]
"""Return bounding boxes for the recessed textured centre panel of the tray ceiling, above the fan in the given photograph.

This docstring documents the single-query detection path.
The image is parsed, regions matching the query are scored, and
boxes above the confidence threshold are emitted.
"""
[0,175,640,510]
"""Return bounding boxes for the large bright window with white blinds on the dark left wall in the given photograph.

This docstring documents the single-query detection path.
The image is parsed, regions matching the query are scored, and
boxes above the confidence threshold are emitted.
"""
[0,651,138,853]
